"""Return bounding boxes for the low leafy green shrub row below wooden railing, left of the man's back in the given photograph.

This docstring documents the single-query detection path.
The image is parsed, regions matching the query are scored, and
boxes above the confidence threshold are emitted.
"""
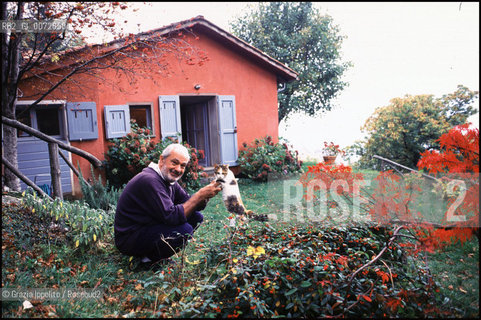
[21,188,114,249]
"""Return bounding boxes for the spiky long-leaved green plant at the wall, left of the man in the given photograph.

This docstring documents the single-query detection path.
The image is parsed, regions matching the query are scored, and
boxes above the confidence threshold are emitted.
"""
[79,166,122,211]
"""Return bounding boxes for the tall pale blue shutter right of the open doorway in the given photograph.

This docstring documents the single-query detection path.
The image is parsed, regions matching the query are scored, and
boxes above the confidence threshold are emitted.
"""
[217,96,238,166]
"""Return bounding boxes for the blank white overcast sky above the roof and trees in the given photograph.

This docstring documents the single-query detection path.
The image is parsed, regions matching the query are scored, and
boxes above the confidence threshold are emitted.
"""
[88,2,479,162]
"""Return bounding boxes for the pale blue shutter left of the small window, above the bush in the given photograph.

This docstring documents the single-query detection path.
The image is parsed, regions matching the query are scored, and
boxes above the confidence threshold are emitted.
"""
[104,105,130,139]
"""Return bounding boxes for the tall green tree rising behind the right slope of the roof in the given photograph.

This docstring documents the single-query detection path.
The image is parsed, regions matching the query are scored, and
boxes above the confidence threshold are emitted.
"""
[231,2,350,122]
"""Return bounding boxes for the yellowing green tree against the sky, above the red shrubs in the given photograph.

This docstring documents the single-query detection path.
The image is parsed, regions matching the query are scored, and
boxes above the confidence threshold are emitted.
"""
[359,85,478,169]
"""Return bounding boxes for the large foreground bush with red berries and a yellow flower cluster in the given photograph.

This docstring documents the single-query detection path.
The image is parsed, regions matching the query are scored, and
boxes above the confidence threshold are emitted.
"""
[175,226,442,318]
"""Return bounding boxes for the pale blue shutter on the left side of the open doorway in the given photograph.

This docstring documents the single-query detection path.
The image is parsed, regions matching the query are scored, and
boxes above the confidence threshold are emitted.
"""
[159,96,182,143]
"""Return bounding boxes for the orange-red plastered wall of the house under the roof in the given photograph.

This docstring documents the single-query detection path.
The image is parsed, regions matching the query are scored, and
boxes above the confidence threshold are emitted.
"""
[18,33,278,194]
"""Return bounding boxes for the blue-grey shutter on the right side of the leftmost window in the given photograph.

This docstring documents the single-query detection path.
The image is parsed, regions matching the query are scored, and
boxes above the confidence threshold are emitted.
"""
[67,102,99,141]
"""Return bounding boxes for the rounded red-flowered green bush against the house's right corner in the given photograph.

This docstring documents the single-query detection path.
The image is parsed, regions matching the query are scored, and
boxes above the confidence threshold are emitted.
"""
[237,136,302,181]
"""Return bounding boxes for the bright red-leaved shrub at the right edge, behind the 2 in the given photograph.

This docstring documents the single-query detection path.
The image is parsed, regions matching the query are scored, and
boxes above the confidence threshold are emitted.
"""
[418,124,479,248]
